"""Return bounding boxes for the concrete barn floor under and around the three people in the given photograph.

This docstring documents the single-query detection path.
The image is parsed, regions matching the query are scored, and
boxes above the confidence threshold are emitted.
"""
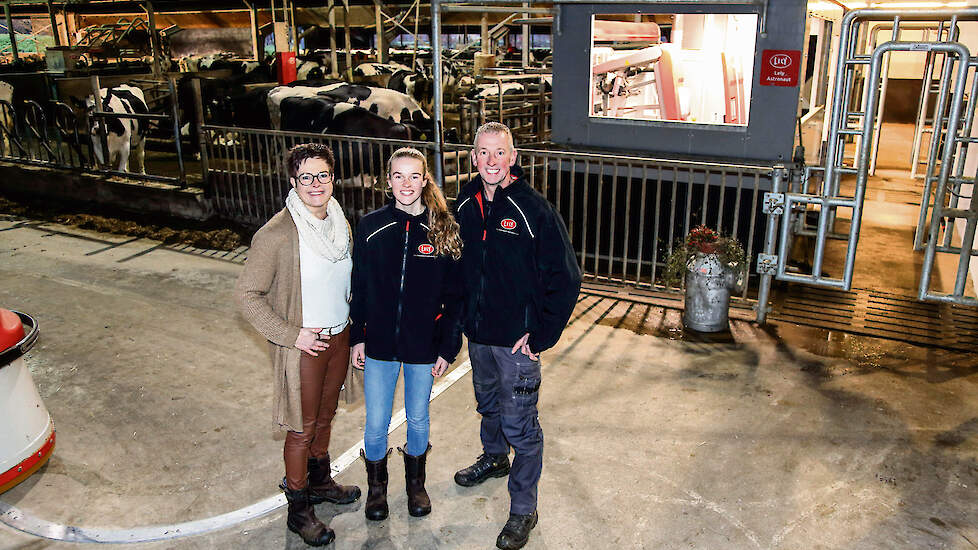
[0,193,978,550]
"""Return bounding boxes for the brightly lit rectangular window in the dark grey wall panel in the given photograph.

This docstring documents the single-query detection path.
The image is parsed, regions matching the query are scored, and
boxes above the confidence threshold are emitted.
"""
[589,13,757,126]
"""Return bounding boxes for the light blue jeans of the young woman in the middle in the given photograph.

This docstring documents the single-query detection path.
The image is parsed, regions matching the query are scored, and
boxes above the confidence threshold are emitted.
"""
[363,357,435,460]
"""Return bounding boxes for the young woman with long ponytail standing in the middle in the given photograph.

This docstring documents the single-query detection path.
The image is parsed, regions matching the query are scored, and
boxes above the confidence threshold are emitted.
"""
[350,147,462,520]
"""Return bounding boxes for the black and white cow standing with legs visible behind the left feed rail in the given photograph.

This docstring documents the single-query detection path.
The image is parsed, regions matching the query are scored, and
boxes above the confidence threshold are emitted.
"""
[85,84,149,174]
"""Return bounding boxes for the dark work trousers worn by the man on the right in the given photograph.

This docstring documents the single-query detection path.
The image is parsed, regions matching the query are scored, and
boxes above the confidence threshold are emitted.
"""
[469,342,543,514]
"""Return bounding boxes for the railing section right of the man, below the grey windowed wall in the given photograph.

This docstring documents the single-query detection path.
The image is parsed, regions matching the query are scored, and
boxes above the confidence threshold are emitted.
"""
[472,144,771,298]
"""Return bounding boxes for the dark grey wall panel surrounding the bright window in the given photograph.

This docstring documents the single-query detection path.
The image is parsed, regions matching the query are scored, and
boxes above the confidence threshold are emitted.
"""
[553,0,806,161]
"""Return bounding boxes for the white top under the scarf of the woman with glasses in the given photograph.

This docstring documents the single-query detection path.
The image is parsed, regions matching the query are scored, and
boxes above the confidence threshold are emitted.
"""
[299,232,353,334]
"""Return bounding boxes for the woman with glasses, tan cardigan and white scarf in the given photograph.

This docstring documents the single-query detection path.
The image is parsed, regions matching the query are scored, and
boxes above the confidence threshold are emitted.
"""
[235,143,360,546]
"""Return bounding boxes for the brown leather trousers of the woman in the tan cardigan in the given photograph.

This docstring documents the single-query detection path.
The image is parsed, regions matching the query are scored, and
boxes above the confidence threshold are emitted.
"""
[283,326,350,490]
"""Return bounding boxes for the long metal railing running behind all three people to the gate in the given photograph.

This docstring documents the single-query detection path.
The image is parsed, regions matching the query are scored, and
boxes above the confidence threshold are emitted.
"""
[202,125,771,298]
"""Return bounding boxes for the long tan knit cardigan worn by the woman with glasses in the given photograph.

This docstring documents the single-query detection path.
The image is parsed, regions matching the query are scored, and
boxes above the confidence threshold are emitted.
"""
[234,208,346,432]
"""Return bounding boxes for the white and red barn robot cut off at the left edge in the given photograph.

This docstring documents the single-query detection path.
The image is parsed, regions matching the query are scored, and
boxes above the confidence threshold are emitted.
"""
[0,309,54,493]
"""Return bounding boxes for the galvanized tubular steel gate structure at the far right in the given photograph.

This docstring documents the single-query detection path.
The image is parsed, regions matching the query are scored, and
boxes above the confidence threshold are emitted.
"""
[758,8,978,320]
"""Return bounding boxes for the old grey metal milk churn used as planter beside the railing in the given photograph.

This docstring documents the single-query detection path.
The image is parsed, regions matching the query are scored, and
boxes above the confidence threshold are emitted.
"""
[683,252,736,332]
